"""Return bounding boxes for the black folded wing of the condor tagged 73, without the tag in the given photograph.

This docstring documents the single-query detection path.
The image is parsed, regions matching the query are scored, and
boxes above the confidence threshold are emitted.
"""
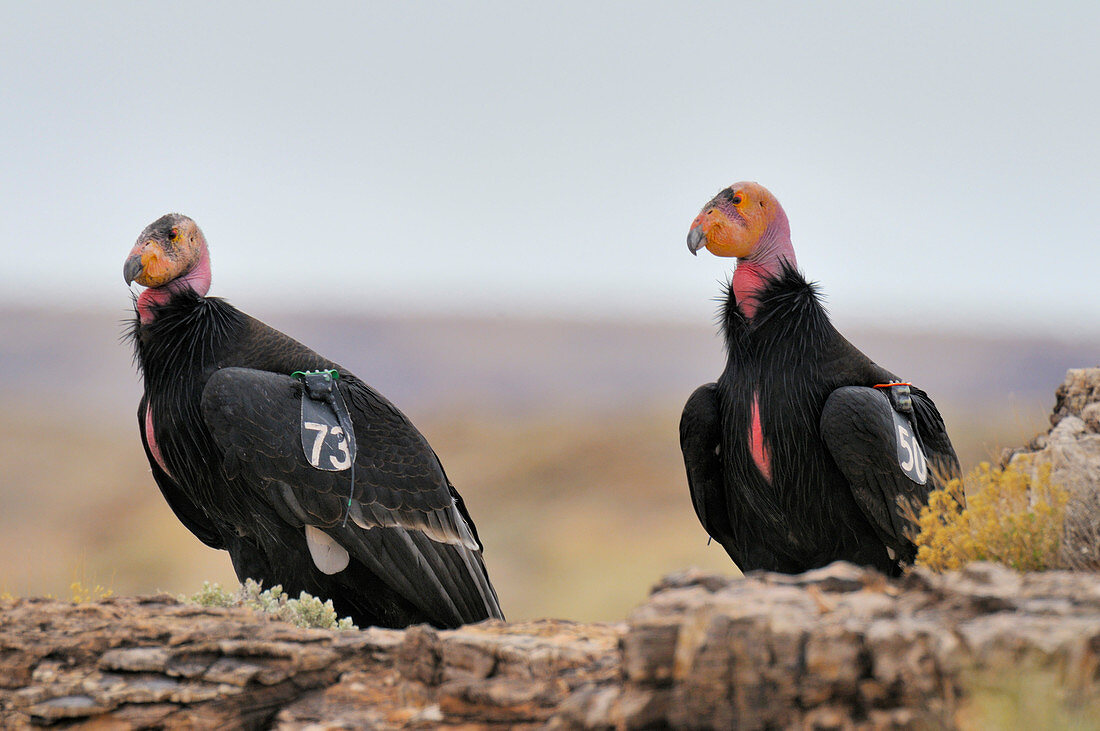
[202,368,502,625]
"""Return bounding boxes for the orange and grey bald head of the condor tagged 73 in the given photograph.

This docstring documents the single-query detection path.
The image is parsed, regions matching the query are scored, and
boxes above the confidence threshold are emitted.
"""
[122,213,207,287]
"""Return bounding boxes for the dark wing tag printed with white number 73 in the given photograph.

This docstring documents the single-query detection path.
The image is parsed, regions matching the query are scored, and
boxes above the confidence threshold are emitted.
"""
[295,370,355,472]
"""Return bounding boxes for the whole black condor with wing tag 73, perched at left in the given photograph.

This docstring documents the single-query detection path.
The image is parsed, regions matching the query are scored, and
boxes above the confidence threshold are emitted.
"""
[123,213,503,628]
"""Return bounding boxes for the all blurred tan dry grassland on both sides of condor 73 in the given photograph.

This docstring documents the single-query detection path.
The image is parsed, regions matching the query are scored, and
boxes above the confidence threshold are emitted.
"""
[0,405,736,621]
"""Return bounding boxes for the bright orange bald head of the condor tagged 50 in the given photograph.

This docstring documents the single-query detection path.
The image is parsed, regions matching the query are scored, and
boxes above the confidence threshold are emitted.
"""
[688,182,790,258]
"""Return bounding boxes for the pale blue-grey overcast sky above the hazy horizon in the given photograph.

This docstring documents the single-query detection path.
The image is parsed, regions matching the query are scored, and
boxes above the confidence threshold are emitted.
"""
[0,0,1100,337]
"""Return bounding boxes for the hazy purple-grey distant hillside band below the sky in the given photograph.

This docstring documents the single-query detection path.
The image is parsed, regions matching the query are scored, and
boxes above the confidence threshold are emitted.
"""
[0,307,1100,418]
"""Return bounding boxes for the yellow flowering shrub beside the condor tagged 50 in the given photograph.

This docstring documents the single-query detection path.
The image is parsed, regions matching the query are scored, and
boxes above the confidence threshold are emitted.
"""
[916,462,1069,572]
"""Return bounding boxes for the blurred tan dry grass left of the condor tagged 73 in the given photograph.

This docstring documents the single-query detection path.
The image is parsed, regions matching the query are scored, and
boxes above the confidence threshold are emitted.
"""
[0,405,235,597]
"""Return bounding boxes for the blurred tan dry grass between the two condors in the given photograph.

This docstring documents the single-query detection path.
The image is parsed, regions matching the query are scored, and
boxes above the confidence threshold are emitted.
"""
[424,406,737,620]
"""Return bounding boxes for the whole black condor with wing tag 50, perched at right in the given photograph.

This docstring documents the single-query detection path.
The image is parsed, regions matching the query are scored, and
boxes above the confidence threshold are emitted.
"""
[680,182,959,575]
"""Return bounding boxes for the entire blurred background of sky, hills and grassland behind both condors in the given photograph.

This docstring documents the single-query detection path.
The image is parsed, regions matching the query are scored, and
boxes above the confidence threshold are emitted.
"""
[0,2,1100,620]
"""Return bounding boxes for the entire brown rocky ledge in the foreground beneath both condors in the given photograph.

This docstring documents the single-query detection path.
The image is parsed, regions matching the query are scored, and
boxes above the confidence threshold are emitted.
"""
[0,563,1100,729]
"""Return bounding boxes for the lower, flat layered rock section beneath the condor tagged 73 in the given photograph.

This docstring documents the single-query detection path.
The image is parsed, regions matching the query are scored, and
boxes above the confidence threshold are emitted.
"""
[0,596,623,729]
